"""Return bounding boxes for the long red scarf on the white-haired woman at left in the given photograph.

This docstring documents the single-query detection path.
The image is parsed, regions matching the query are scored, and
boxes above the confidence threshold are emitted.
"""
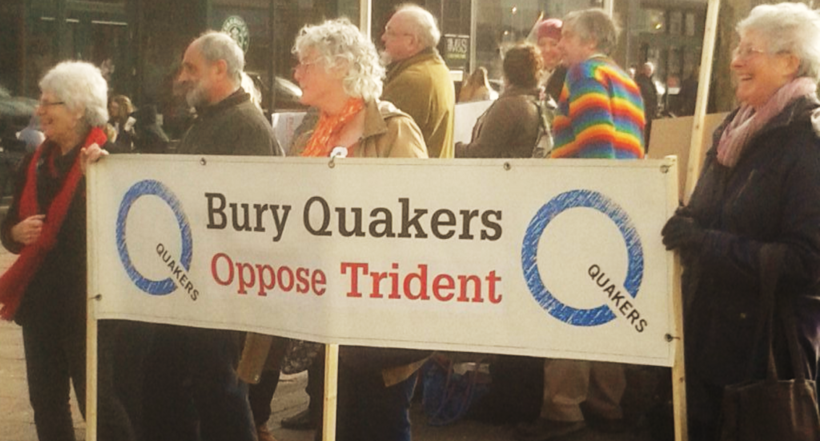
[0,127,106,320]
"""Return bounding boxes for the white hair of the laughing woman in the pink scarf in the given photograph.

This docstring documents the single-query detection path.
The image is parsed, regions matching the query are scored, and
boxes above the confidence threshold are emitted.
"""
[737,3,820,82]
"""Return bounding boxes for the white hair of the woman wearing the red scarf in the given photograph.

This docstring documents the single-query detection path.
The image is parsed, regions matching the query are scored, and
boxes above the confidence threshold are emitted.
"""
[40,61,108,127]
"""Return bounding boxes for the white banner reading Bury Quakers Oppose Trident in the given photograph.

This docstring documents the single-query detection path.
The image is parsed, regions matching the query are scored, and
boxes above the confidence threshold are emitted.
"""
[88,155,677,366]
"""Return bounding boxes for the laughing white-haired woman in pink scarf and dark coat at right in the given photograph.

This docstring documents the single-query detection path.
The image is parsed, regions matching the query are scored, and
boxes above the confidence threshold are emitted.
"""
[662,3,820,440]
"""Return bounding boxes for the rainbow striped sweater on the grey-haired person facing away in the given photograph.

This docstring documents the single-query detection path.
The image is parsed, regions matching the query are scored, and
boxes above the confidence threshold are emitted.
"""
[550,56,644,159]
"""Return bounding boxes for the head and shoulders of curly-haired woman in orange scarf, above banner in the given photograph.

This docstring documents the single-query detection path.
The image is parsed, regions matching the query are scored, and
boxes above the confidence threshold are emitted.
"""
[293,18,427,158]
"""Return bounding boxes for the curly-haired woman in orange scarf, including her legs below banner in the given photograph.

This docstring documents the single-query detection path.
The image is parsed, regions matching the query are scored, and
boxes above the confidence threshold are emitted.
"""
[292,19,428,441]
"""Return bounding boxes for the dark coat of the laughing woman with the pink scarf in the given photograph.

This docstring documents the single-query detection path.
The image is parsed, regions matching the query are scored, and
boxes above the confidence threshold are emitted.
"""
[683,97,820,392]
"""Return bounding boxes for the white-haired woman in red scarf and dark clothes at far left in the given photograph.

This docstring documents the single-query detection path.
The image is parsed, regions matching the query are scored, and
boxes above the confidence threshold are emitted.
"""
[0,61,134,441]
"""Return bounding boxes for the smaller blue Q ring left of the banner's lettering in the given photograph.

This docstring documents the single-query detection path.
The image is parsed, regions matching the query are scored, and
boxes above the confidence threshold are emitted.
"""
[117,180,193,296]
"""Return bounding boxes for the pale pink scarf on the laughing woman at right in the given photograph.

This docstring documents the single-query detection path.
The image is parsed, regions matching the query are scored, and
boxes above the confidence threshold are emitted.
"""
[718,77,817,167]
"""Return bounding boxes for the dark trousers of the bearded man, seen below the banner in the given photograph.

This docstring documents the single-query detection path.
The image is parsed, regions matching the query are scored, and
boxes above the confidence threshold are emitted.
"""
[143,325,256,441]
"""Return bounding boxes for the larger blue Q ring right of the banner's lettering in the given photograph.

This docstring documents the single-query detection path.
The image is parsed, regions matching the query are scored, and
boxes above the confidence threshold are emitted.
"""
[521,190,644,326]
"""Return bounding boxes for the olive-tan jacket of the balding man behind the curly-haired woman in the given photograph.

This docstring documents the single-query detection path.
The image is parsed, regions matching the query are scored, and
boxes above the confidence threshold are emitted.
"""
[382,48,456,158]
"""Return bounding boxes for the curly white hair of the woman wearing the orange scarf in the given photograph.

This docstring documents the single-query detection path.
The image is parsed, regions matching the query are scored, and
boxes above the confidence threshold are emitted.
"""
[291,18,385,101]
